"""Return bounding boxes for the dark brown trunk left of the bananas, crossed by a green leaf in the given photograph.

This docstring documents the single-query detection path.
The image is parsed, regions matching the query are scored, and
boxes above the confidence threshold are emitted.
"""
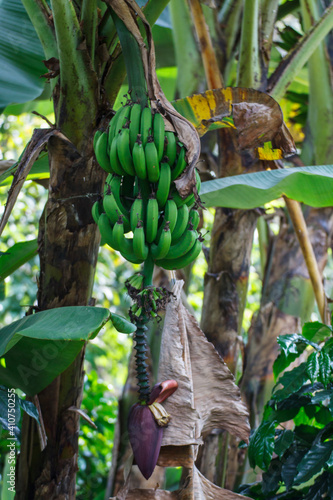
[15,138,105,500]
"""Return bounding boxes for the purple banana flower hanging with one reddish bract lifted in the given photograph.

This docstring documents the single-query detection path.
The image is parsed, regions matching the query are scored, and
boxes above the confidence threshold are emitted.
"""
[128,380,178,479]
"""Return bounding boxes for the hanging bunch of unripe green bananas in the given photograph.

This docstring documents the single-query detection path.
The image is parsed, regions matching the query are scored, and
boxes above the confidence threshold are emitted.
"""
[92,103,203,269]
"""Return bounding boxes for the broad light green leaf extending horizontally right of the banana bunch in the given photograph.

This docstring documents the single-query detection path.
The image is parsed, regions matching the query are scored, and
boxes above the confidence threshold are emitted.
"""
[200,165,333,209]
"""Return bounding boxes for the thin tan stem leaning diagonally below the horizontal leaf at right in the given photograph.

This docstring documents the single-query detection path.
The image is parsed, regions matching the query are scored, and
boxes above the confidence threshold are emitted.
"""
[284,196,329,324]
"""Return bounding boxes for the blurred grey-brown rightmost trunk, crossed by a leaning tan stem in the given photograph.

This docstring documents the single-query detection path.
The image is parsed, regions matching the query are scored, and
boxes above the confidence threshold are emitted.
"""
[241,207,333,426]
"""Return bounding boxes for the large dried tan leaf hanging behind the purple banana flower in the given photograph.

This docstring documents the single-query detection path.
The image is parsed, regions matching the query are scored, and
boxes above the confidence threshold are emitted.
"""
[159,281,250,446]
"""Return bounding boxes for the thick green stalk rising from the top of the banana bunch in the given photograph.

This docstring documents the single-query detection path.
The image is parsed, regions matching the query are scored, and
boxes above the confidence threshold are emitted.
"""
[111,11,147,107]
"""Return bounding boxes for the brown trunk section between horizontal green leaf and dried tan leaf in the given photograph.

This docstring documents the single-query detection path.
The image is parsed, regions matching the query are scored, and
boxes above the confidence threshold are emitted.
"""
[201,208,258,373]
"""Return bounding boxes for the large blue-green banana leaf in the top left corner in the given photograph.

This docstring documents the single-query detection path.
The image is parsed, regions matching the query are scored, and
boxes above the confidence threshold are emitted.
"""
[0,0,46,110]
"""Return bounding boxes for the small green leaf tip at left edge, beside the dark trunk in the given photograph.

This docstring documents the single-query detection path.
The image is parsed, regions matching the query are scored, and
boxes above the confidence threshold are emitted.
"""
[0,239,38,283]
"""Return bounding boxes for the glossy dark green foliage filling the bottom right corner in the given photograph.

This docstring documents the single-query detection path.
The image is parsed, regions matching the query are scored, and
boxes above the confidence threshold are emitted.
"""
[240,322,333,500]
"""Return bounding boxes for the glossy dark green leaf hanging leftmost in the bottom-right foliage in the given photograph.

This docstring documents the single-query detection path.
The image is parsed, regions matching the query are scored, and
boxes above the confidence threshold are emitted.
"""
[249,422,275,470]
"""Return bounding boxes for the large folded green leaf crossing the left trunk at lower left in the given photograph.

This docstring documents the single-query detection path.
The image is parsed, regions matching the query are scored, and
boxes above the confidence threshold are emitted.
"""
[0,306,110,396]
